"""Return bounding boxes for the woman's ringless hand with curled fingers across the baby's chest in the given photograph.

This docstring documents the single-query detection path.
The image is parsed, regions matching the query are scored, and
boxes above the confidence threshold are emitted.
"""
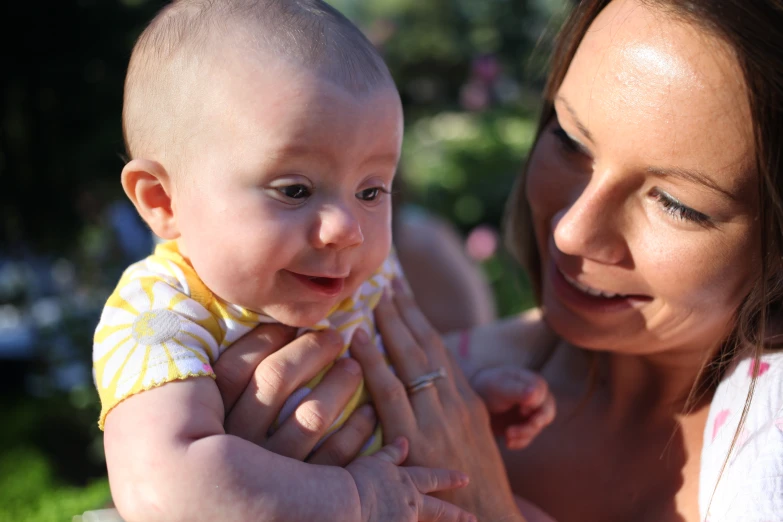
[214,324,375,464]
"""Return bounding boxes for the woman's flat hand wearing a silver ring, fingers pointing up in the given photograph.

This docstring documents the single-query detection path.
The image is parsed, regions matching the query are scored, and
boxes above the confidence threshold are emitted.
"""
[351,285,524,522]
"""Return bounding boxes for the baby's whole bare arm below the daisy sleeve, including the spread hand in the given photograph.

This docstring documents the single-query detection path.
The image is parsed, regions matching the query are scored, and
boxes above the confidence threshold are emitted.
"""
[104,377,471,522]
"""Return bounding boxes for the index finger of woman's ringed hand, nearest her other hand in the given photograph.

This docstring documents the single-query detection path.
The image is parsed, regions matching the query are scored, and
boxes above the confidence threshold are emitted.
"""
[351,329,416,437]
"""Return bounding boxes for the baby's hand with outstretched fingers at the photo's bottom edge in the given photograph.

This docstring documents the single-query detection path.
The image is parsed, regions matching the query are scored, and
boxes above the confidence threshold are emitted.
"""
[345,437,476,522]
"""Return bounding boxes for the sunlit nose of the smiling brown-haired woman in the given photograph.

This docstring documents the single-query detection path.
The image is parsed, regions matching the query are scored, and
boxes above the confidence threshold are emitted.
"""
[552,175,628,265]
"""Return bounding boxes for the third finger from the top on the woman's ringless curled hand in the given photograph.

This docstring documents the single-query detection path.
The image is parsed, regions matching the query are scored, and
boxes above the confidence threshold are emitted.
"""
[264,359,362,460]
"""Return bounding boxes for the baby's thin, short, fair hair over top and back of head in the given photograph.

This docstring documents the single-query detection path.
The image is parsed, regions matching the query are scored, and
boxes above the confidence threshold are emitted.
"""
[123,0,392,158]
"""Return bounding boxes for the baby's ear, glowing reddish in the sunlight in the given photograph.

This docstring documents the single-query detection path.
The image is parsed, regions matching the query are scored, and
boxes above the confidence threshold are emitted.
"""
[122,159,179,239]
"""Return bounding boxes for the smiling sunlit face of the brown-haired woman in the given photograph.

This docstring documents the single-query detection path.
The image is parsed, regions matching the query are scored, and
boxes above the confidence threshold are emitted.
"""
[527,0,759,353]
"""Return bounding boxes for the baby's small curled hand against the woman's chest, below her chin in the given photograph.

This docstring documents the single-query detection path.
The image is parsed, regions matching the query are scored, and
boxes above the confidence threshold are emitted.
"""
[471,366,555,449]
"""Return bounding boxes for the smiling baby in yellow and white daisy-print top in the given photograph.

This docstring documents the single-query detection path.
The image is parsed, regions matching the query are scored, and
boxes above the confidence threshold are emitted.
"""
[93,0,556,522]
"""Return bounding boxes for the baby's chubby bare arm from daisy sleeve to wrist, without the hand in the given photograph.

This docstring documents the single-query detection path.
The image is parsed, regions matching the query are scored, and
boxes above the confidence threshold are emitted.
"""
[104,377,359,522]
